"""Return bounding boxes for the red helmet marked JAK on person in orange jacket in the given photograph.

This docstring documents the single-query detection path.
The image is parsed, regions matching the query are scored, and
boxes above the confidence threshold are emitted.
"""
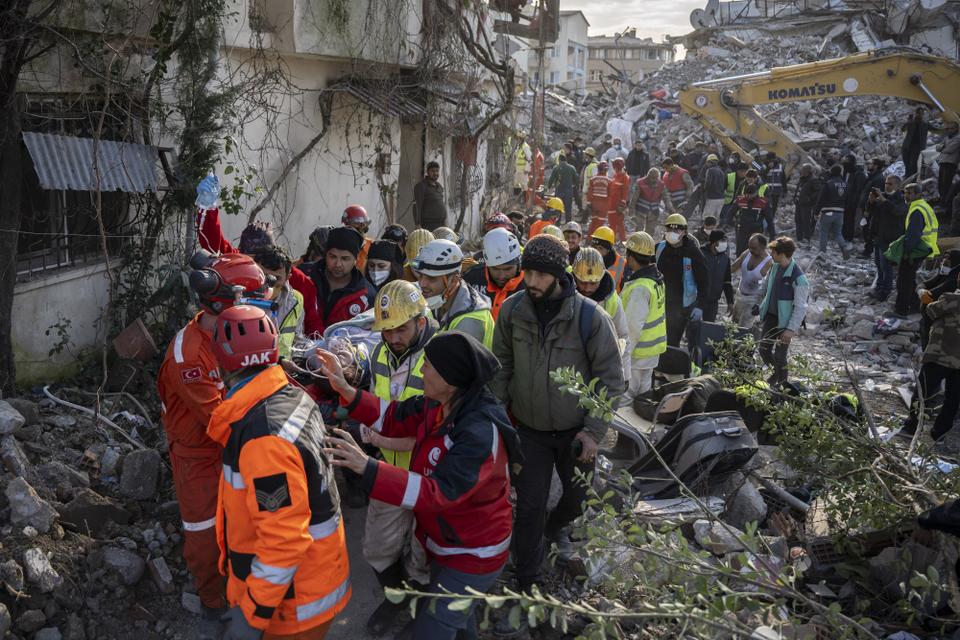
[213,304,280,373]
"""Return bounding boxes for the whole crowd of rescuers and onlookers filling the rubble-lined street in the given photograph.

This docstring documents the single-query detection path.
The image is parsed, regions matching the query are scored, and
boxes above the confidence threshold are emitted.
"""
[158,119,960,640]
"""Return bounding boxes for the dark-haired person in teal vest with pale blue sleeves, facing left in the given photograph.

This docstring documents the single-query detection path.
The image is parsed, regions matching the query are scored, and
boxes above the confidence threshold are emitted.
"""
[759,236,810,386]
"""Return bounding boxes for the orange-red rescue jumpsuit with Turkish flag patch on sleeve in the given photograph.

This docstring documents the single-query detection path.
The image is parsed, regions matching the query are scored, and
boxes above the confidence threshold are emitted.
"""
[157,313,232,609]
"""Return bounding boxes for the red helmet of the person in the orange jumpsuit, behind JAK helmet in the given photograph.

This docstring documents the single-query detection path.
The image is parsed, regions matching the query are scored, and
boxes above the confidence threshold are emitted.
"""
[189,251,267,313]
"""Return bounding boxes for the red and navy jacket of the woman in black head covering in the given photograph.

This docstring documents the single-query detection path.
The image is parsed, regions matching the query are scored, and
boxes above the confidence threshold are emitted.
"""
[344,390,519,574]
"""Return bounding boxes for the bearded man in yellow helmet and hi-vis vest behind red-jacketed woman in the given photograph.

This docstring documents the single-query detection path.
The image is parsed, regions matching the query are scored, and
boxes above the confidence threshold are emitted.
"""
[357,280,436,636]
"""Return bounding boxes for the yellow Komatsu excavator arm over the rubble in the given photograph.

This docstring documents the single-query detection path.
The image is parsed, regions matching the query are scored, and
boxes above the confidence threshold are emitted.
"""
[680,47,960,175]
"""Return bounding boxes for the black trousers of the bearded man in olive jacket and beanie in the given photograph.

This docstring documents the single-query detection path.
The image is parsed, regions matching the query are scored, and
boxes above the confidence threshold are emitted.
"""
[511,426,593,591]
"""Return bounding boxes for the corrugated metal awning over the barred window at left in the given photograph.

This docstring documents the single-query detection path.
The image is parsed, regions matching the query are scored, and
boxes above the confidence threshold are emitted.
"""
[23,131,160,193]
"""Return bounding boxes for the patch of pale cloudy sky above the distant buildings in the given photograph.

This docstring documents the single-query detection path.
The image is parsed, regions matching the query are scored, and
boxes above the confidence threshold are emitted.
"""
[560,0,707,42]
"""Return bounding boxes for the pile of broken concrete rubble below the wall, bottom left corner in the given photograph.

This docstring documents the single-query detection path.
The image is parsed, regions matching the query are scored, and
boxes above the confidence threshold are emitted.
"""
[0,391,199,640]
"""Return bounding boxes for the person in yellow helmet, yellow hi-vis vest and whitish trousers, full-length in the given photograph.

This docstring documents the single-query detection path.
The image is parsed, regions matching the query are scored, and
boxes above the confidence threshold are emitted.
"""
[621,231,667,404]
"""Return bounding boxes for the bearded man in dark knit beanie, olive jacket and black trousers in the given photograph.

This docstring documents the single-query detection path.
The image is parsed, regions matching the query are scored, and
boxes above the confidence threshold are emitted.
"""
[488,236,624,593]
